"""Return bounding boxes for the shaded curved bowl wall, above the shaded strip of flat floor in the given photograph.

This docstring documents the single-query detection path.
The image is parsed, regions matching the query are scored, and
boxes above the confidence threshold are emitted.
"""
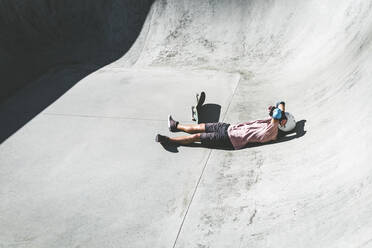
[0,0,153,100]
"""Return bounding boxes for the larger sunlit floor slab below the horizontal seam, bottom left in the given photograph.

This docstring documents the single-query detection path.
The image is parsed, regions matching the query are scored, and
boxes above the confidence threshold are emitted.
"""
[0,115,208,247]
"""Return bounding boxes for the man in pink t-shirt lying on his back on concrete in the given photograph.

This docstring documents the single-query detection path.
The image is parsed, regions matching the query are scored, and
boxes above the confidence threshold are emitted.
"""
[155,102,287,150]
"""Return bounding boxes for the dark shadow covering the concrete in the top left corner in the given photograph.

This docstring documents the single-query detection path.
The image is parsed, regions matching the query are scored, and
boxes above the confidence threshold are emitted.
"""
[0,0,153,143]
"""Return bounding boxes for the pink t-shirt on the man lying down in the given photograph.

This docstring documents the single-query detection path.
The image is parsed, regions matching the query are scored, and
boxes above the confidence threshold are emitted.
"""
[227,118,279,149]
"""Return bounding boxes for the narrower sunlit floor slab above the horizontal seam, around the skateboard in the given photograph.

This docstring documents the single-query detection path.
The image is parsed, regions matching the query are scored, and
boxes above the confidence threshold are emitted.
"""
[44,68,240,124]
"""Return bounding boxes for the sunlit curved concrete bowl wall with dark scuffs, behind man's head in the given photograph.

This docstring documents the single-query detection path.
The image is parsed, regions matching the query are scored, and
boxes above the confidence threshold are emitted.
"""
[118,0,372,247]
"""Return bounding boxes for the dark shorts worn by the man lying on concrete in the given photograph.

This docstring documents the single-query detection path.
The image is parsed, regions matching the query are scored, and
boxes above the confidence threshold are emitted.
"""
[200,122,234,149]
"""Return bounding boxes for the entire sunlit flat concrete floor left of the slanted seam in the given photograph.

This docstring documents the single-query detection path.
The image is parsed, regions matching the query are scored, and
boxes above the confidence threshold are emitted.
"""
[0,69,240,247]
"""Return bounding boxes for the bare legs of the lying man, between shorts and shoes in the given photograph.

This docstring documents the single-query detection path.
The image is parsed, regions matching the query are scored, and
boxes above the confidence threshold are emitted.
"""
[169,123,205,145]
